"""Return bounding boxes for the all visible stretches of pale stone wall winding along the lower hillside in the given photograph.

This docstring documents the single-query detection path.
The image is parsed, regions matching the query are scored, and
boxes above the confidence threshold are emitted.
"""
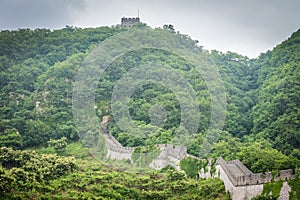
[101,116,297,200]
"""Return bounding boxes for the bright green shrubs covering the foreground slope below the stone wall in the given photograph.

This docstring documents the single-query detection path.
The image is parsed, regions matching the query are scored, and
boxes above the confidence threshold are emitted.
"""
[0,143,229,200]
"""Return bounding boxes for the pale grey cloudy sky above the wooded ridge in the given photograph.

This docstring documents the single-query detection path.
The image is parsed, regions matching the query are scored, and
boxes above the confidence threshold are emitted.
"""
[0,0,300,58]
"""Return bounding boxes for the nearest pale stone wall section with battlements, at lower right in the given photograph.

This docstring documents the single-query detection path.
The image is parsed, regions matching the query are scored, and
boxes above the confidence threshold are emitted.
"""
[215,157,297,200]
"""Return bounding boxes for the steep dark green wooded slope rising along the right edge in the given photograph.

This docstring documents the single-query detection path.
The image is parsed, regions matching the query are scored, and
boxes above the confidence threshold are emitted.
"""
[252,30,300,155]
